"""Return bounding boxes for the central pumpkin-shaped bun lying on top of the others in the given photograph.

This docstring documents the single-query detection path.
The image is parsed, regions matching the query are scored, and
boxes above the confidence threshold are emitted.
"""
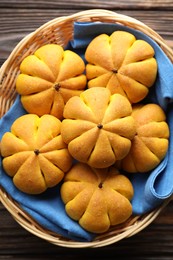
[61,87,136,168]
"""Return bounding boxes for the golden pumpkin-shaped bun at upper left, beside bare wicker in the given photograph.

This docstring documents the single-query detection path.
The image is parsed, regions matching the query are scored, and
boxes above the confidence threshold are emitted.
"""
[16,44,86,119]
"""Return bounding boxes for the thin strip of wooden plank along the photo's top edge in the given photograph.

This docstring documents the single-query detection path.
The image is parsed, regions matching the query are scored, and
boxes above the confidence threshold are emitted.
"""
[0,0,173,10]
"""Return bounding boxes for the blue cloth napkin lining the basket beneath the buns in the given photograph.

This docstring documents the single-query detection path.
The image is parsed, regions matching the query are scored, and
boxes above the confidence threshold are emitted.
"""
[0,22,173,241]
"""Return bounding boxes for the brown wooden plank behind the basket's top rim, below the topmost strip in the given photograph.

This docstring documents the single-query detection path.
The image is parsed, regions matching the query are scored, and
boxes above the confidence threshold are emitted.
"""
[0,8,173,59]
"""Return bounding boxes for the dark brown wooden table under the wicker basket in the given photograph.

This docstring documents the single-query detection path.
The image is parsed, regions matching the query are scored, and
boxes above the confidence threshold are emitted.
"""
[0,0,173,260]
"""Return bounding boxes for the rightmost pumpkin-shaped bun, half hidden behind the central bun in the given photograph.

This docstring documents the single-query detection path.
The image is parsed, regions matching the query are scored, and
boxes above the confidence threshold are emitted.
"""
[121,104,169,172]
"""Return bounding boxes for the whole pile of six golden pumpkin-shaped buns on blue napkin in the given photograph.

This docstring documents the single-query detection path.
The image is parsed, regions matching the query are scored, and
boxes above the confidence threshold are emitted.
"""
[1,31,169,233]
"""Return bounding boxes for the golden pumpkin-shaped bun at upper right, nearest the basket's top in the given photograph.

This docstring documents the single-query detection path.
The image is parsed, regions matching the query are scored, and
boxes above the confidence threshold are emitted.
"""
[85,31,157,103]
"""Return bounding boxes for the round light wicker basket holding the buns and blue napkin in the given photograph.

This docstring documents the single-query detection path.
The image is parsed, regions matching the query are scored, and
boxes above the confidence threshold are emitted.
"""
[0,9,173,248]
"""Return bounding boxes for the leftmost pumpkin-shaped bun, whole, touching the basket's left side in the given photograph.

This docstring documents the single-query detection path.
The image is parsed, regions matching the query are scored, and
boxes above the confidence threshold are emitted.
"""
[1,114,72,194]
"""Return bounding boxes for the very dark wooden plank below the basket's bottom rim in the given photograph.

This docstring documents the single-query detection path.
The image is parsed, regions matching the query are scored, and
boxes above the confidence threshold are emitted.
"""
[0,202,173,260]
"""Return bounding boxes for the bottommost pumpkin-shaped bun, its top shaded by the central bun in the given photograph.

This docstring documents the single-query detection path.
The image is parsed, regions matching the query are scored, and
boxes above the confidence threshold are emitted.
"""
[61,163,133,233]
